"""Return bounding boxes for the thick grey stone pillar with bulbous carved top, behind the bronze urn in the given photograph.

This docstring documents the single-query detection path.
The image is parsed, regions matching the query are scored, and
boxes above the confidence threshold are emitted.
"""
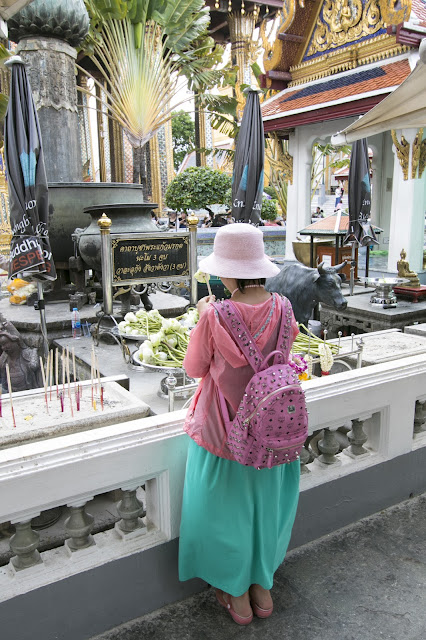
[8,0,89,182]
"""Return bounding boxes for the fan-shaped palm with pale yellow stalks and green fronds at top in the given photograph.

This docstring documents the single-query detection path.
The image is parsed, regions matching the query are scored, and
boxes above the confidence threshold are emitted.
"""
[80,0,233,148]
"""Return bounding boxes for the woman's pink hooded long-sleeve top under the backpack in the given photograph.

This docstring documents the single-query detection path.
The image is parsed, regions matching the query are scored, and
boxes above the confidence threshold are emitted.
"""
[183,293,299,460]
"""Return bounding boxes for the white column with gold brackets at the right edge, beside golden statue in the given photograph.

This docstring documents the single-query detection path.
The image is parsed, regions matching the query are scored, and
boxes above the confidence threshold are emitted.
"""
[388,129,426,273]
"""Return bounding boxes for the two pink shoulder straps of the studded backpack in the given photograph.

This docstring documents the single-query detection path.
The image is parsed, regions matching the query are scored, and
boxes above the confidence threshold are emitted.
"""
[213,294,291,372]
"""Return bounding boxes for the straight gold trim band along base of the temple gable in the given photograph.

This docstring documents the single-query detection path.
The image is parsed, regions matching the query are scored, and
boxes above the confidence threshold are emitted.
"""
[288,34,409,87]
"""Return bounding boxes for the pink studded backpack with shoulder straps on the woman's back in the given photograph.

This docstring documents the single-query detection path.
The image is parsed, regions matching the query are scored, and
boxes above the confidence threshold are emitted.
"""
[213,298,308,469]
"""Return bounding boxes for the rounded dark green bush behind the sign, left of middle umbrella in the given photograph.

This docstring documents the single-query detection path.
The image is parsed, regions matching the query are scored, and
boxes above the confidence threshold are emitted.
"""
[166,167,232,211]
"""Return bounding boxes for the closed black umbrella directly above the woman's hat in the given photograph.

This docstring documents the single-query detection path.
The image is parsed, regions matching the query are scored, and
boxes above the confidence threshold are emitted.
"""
[232,89,265,224]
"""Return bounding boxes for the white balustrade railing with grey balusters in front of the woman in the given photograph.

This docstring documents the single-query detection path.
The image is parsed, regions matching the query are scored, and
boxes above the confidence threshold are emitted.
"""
[0,355,426,601]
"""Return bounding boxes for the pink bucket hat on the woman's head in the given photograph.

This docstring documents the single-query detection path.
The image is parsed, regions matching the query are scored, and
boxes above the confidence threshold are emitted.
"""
[199,223,280,280]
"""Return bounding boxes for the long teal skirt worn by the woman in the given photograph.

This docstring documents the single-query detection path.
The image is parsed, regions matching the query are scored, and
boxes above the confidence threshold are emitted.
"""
[179,439,300,597]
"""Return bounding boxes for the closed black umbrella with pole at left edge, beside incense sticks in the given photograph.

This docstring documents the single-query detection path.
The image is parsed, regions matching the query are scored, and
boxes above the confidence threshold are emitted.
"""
[4,56,56,350]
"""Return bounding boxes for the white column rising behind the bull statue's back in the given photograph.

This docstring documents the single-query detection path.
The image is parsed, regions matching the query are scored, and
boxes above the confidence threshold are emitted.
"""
[285,127,315,260]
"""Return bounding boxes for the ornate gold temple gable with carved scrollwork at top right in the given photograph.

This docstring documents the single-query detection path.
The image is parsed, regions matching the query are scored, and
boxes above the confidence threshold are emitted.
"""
[260,0,412,86]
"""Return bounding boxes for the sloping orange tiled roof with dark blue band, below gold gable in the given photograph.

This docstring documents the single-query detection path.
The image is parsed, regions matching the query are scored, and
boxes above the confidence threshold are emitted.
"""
[262,59,411,119]
